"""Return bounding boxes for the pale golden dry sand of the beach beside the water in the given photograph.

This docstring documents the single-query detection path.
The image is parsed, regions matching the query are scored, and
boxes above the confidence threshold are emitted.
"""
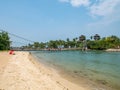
[0,52,89,90]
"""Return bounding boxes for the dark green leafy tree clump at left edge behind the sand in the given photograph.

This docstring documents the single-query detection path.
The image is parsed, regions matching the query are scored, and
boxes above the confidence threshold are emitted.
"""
[0,32,10,50]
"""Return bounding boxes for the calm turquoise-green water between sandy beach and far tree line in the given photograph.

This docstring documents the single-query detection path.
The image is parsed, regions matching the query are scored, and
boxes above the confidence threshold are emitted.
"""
[32,51,120,90]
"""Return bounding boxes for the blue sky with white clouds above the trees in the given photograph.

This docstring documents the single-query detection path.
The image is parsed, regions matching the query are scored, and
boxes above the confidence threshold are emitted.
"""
[0,0,120,45]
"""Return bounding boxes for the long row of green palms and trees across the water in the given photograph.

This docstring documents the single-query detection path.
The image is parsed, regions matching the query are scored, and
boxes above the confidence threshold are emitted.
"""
[26,34,120,50]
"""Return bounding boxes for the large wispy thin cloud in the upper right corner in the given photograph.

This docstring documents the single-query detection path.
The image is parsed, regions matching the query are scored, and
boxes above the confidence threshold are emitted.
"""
[88,0,120,27]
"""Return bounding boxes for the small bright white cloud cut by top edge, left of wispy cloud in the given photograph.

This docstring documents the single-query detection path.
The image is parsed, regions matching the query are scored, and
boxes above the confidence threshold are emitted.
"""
[59,0,90,7]
